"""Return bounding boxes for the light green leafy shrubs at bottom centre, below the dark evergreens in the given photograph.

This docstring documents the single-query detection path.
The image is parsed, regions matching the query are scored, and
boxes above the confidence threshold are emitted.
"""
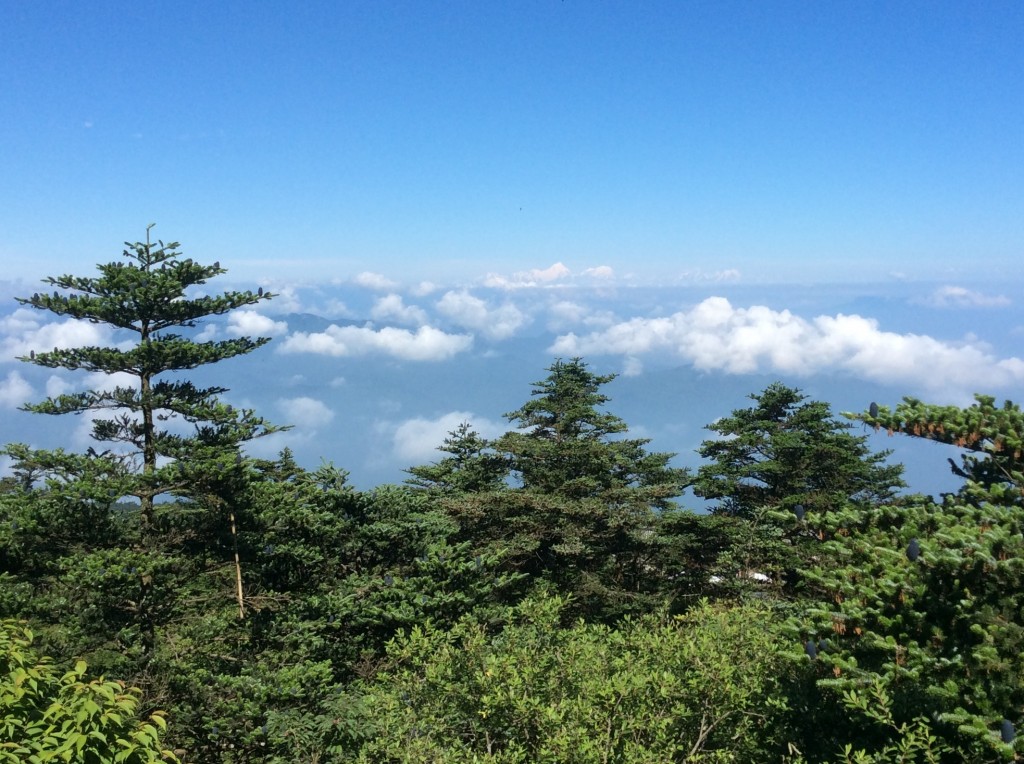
[359,596,792,763]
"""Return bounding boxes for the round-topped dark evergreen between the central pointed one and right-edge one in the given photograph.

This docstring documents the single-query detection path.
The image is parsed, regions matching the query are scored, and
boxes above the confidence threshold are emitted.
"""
[691,382,903,597]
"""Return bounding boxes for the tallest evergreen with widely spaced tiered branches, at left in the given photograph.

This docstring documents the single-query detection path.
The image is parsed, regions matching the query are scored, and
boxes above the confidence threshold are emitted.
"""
[7,226,276,532]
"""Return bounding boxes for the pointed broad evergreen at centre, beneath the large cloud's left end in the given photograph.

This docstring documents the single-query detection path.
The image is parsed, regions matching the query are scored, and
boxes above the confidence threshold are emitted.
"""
[443,358,686,618]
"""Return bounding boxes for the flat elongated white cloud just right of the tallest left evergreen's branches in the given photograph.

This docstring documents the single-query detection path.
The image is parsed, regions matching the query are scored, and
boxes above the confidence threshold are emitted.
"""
[278,326,473,360]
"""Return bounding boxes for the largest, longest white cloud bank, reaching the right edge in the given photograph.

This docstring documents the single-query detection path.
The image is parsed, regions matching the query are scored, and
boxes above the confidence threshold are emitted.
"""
[550,297,1024,394]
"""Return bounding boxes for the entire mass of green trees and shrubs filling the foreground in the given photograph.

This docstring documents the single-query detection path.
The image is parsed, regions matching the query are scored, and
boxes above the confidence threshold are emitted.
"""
[0,243,1024,764]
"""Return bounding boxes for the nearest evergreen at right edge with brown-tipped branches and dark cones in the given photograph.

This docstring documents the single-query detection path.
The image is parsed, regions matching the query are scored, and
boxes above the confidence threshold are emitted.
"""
[795,396,1024,762]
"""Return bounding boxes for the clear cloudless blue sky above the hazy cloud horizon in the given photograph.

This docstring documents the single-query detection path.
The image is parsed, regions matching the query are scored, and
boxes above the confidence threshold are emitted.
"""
[0,0,1024,282]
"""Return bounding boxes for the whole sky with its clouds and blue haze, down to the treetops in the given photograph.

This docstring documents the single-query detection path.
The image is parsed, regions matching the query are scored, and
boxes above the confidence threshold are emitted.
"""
[0,0,1024,484]
